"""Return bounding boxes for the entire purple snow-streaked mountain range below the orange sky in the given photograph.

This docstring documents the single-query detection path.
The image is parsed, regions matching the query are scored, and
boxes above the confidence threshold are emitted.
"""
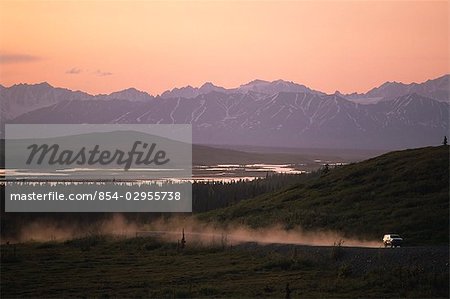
[0,75,450,149]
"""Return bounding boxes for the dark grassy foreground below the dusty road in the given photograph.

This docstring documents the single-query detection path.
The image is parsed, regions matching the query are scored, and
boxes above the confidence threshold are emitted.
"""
[1,236,449,298]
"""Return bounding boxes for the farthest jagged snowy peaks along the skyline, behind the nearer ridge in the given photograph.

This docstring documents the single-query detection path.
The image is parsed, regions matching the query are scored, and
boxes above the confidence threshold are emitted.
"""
[0,74,450,112]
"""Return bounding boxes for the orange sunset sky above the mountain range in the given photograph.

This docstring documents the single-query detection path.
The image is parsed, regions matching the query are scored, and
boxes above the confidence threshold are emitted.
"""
[0,1,449,94]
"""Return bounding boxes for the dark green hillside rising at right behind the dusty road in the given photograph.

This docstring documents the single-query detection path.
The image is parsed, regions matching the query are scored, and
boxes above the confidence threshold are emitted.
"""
[198,146,449,245]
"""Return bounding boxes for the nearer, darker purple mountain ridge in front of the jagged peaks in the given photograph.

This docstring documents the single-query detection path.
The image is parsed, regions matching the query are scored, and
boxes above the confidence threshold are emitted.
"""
[9,92,449,149]
